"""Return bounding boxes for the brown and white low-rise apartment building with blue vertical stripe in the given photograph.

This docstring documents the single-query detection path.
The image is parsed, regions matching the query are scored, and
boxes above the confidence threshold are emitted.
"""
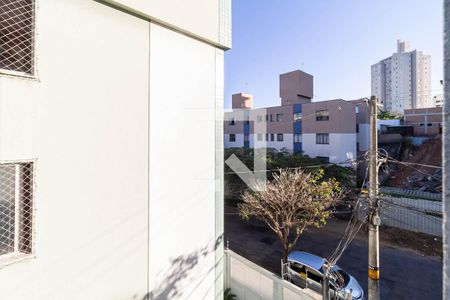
[224,70,369,163]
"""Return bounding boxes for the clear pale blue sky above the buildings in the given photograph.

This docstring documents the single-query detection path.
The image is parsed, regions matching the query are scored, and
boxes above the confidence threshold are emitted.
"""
[225,0,443,108]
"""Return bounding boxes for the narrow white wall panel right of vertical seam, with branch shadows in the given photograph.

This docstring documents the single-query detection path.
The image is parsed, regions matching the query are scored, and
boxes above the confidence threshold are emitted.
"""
[149,24,223,299]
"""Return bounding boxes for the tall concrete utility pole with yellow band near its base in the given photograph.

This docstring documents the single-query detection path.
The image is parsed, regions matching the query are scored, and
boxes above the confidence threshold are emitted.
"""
[368,96,381,300]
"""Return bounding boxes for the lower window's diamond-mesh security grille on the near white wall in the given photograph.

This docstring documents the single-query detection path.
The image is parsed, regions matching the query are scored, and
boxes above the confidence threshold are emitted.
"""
[0,162,33,256]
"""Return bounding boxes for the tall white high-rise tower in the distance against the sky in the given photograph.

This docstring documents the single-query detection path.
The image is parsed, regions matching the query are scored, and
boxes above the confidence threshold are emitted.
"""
[371,40,433,114]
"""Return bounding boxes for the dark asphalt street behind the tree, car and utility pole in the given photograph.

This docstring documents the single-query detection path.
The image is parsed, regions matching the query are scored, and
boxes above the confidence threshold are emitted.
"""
[225,212,442,300]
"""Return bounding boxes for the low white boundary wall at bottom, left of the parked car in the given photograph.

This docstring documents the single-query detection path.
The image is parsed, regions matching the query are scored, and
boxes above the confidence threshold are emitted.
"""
[225,250,322,300]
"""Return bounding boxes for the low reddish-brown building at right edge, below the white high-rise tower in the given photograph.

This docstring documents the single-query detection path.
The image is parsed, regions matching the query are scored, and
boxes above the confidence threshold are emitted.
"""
[404,107,443,136]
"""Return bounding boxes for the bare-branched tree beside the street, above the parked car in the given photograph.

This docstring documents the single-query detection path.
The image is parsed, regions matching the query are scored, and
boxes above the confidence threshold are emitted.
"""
[239,170,343,262]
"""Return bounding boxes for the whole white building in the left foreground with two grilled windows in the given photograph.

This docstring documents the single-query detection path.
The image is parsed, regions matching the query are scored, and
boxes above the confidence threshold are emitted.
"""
[0,0,231,300]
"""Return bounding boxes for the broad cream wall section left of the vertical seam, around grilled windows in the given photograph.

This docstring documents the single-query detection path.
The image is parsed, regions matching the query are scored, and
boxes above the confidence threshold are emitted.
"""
[0,0,149,300]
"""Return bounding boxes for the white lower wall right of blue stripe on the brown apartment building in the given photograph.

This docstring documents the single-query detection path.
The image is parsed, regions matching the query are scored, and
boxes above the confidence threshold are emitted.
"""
[302,133,356,163]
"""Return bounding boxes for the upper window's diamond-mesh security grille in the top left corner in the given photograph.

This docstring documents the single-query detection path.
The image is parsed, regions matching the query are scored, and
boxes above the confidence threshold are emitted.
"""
[0,0,35,75]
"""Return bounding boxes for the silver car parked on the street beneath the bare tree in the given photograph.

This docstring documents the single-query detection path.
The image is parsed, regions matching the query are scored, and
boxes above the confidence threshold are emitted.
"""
[287,251,364,300]
